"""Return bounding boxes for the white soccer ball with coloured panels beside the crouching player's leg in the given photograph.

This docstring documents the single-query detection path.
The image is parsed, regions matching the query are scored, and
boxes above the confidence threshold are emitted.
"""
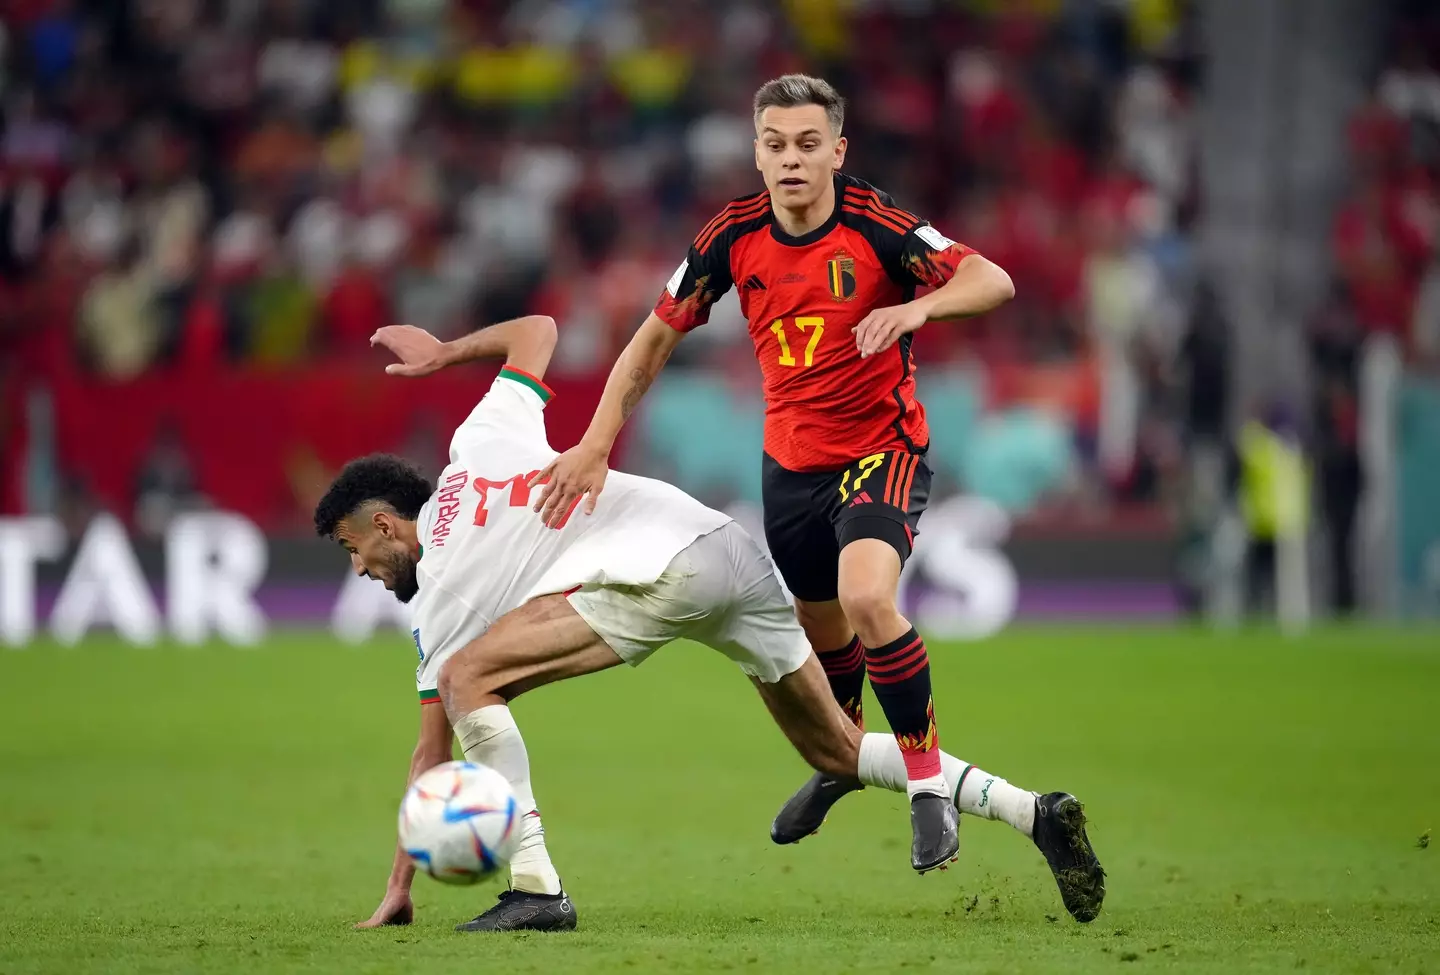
[400,762,521,884]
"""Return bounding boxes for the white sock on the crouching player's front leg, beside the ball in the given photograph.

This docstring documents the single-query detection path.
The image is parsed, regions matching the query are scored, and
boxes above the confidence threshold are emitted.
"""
[455,704,560,894]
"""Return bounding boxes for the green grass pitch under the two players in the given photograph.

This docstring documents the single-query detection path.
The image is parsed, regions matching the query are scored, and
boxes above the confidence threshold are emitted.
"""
[0,628,1440,975]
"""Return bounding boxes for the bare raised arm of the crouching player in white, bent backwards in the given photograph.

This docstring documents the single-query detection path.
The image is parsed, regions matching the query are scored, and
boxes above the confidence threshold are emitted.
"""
[370,315,556,379]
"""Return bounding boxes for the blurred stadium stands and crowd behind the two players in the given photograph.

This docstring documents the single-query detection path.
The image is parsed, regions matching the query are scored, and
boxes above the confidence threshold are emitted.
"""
[0,0,1440,630]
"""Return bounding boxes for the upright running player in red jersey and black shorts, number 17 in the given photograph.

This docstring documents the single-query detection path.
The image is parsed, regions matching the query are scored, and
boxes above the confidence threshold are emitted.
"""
[537,75,1103,890]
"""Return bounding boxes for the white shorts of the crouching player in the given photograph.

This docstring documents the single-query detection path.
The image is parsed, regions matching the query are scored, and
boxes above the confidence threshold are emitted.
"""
[569,521,811,684]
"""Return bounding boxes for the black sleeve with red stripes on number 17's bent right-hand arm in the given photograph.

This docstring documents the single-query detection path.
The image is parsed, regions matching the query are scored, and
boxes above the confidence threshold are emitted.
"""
[841,180,975,288]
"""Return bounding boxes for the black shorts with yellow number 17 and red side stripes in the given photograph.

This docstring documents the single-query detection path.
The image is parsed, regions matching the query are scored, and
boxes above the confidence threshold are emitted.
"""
[762,451,930,602]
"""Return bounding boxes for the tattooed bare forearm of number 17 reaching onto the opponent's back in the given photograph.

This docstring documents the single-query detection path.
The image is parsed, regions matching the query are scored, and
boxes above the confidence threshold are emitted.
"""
[530,313,684,529]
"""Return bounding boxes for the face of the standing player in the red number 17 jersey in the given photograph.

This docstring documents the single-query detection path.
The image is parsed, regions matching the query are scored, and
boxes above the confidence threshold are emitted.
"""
[755,105,845,210]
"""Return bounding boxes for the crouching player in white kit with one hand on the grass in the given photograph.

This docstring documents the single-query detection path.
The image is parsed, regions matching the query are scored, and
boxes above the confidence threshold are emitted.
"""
[324,315,1100,930]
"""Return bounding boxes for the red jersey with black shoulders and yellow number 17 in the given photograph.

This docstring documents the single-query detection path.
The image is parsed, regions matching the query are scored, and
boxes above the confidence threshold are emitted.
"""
[655,173,973,471]
